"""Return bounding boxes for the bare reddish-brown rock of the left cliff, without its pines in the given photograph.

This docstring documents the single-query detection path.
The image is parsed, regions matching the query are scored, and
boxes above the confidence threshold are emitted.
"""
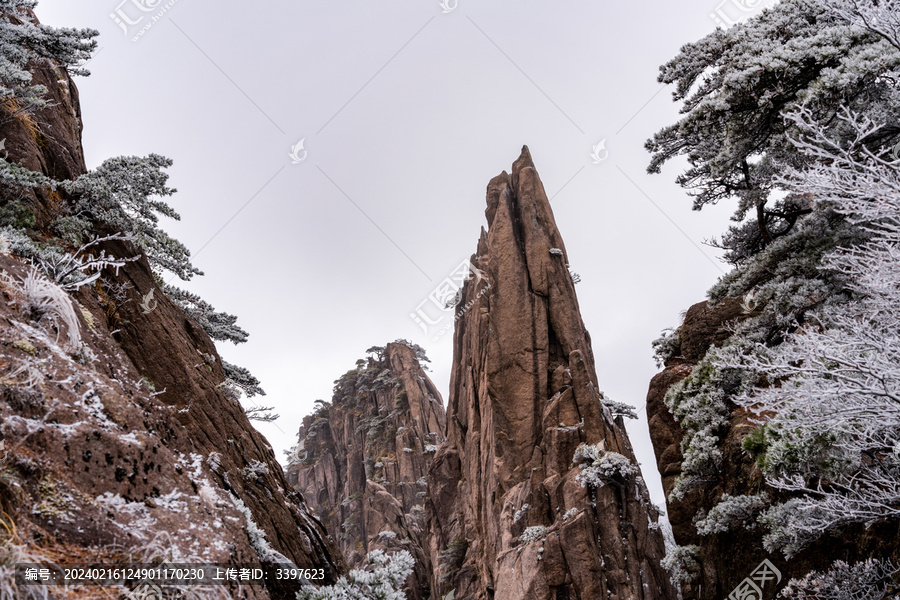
[0,43,345,598]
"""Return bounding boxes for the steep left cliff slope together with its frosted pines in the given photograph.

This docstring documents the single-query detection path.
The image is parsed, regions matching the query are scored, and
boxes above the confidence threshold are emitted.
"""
[0,0,346,600]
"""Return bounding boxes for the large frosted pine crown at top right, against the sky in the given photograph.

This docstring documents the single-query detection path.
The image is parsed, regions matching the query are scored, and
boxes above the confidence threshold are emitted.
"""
[646,0,900,264]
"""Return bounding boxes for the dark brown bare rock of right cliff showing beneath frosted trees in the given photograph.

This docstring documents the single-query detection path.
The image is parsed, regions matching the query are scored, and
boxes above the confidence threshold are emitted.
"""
[647,297,900,600]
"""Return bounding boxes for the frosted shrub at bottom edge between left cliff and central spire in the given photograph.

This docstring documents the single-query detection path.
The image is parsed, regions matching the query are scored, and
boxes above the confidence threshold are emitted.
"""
[297,550,414,600]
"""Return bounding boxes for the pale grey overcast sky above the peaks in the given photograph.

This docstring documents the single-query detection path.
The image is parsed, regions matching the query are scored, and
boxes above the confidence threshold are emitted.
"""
[37,0,760,503]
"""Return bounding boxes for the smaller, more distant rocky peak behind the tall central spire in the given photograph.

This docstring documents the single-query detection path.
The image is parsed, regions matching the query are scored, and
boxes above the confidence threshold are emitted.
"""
[287,342,446,600]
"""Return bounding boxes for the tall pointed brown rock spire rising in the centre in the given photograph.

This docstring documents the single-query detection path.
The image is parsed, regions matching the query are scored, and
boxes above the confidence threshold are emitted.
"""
[426,148,675,600]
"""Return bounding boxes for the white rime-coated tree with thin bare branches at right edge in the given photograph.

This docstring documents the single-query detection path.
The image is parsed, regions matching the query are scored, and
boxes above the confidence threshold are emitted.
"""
[733,110,900,556]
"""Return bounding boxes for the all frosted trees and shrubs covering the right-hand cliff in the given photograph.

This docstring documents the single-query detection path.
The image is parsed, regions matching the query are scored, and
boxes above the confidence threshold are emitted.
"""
[647,0,900,598]
